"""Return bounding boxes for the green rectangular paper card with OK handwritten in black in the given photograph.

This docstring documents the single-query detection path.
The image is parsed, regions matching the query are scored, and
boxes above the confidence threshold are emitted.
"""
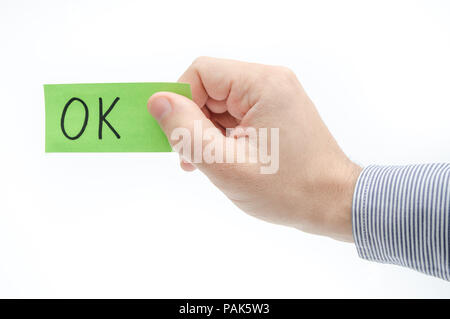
[44,83,192,152]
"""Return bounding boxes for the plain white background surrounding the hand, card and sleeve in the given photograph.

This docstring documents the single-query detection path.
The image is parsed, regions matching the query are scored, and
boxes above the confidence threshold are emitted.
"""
[0,0,450,298]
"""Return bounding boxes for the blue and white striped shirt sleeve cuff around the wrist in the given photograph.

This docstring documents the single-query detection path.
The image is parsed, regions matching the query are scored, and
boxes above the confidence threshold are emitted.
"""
[352,164,450,280]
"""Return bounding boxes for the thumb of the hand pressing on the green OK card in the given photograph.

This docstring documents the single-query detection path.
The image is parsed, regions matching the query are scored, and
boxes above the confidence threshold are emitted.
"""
[147,92,225,169]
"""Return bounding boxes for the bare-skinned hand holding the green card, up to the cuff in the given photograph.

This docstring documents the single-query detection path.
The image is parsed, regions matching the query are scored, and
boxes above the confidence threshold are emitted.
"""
[148,57,361,242]
